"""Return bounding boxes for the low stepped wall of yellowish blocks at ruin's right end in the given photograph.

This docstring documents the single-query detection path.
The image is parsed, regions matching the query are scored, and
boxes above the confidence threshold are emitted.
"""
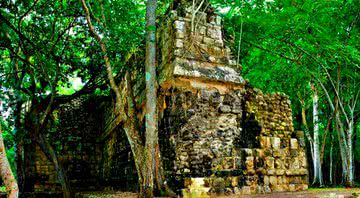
[235,89,308,192]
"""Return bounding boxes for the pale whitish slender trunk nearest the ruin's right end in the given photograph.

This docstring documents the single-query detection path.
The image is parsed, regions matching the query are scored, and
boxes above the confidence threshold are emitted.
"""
[312,86,323,186]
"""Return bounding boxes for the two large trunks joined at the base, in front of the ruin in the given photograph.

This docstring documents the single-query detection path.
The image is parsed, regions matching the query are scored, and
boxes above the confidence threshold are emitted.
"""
[81,0,172,197]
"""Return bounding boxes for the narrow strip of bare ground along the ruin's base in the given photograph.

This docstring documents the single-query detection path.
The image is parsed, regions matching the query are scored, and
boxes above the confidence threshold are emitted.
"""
[77,188,360,198]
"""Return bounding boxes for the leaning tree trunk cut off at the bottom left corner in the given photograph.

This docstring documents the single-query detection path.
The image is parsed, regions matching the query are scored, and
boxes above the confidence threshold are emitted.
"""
[0,117,19,198]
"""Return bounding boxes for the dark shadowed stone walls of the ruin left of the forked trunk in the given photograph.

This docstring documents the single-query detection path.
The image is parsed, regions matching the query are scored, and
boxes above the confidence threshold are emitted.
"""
[25,96,138,192]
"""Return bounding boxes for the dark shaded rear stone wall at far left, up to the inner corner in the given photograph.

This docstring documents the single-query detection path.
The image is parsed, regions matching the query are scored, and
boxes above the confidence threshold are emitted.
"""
[26,96,104,191]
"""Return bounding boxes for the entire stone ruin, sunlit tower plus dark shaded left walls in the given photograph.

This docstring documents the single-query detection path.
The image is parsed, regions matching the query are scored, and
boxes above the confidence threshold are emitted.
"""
[25,2,308,197]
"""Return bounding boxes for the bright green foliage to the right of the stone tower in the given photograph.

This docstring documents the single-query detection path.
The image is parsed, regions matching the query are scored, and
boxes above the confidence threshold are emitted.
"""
[212,0,360,186]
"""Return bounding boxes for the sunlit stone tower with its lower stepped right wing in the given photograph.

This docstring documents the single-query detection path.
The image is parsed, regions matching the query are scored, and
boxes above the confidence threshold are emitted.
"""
[157,1,308,196]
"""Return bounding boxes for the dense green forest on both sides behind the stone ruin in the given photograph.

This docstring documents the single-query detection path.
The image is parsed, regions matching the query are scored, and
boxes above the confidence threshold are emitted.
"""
[0,0,360,196]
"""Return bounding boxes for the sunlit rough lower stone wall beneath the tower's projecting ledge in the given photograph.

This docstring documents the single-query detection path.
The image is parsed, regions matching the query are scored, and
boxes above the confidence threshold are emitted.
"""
[160,86,308,194]
